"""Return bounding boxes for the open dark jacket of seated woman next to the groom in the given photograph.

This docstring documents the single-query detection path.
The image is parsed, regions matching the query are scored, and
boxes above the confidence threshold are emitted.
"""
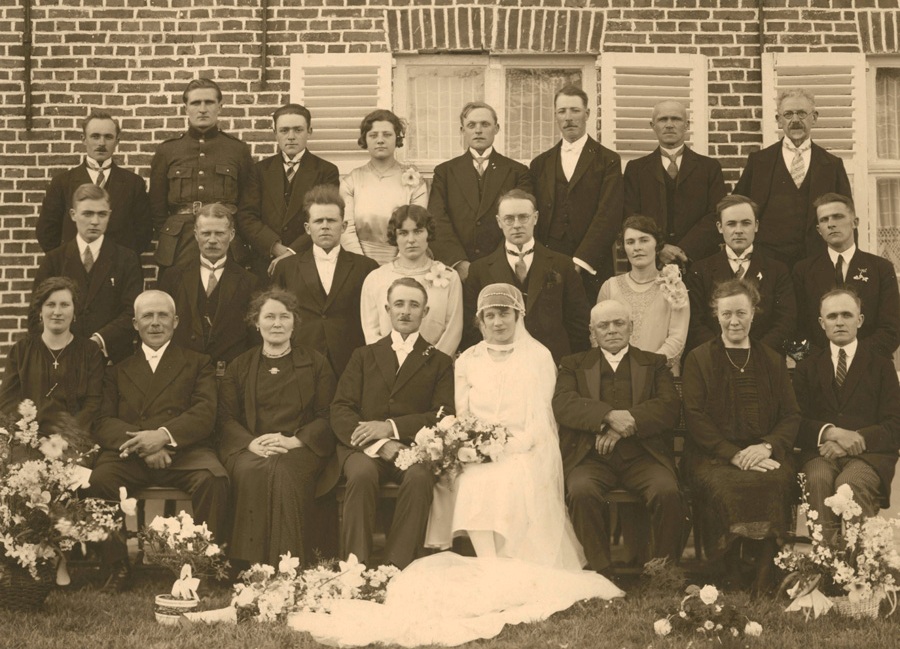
[216,345,335,495]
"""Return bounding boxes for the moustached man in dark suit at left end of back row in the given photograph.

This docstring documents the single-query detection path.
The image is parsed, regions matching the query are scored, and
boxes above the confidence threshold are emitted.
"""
[36,111,153,255]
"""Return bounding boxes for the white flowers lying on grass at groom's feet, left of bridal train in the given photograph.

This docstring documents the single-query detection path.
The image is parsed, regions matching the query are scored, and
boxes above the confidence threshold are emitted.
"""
[231,553,400,622]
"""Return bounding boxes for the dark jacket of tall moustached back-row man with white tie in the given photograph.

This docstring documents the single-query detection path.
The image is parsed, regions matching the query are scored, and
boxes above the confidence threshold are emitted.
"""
[531,136,624,284]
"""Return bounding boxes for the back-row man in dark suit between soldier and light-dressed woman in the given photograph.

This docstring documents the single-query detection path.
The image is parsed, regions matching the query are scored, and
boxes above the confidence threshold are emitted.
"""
[236,104,340,282]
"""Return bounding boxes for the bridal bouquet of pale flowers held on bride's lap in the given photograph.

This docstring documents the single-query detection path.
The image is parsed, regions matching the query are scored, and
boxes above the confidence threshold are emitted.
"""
[394,415,510,477]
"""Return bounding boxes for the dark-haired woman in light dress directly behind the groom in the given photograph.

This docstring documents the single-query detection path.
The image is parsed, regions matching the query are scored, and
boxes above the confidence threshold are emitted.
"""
[359,205,463,358]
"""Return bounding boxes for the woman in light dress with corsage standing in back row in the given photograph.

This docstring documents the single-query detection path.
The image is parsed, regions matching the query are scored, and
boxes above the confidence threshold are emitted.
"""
[341,109,428,264]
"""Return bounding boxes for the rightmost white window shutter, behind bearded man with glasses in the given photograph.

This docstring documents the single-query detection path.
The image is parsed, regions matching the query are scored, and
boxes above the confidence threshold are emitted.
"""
[762,52,873,250]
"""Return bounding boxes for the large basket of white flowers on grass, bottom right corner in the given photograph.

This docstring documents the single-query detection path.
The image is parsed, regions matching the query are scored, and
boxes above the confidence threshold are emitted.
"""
[775,473,900,618]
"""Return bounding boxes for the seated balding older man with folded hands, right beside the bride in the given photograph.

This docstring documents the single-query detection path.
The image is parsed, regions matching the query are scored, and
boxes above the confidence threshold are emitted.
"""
[553,300,687,573]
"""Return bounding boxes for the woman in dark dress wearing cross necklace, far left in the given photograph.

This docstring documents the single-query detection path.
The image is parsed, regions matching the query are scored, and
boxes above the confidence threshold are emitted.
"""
[0,277,103,435]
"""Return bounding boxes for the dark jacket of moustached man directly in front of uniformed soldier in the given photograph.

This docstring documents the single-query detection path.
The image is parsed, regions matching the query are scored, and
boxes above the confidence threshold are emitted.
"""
[159,257,256,364]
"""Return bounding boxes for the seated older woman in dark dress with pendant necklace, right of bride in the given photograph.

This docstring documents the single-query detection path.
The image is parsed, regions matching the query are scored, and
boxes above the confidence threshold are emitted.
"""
[682,279,800,594]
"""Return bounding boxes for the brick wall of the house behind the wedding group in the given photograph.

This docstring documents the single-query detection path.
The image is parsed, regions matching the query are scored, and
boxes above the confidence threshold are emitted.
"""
[0,0,900,356]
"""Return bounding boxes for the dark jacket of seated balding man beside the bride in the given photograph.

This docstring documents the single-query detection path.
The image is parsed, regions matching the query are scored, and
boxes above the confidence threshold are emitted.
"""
[553,347,681,475]
